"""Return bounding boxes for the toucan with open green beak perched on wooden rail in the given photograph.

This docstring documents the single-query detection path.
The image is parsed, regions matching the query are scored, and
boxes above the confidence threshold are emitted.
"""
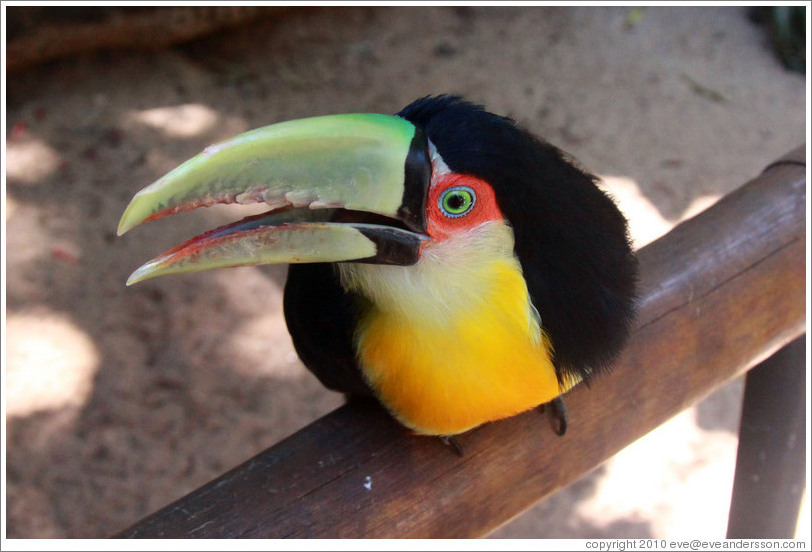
[118,95,637,437]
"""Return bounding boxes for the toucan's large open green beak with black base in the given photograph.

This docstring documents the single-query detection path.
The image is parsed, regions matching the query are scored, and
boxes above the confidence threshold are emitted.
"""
[118,114,431,285]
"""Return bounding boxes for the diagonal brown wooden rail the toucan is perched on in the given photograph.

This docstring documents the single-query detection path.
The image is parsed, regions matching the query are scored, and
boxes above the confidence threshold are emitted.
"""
[119,147,807,538]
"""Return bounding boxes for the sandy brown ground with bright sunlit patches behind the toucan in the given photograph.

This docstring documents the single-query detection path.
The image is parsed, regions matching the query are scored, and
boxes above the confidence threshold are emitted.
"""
[3,7,808,538]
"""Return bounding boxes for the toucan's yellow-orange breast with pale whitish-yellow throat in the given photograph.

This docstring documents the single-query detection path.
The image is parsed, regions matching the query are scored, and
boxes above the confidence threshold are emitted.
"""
[341,223,565,435]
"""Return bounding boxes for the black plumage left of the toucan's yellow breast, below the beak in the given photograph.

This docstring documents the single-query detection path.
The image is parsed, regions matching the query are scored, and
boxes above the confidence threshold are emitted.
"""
[284,263,372,396]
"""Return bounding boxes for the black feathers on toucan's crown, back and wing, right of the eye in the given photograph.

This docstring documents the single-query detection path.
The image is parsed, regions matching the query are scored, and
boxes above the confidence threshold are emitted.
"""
[398,96,637,380]
